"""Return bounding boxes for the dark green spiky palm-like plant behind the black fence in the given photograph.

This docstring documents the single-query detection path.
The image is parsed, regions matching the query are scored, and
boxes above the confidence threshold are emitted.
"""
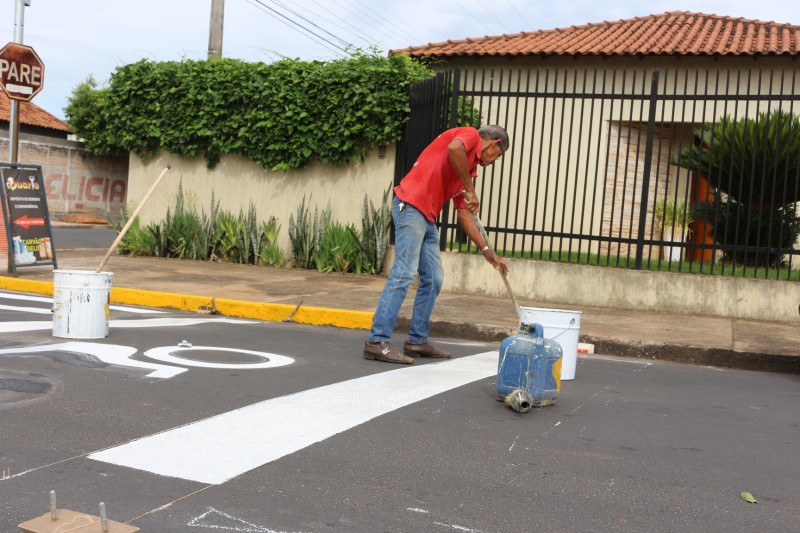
[674,110,800,267]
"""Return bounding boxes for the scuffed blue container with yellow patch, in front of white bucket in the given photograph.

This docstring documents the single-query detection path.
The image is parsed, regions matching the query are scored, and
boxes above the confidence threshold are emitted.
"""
[497,324,563,413]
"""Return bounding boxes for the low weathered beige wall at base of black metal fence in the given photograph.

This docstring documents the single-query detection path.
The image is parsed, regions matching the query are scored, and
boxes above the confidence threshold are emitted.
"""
[428,246,800,324]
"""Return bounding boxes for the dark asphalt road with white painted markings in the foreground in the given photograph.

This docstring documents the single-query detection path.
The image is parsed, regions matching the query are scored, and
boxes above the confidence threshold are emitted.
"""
[0,292,800,533]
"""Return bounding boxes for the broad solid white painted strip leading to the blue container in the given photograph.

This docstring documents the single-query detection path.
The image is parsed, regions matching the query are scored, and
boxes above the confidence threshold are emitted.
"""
[89,351,497,484]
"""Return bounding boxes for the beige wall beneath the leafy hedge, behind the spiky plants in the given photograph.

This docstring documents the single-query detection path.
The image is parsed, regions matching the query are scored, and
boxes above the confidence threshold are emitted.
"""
[128,146,395,253]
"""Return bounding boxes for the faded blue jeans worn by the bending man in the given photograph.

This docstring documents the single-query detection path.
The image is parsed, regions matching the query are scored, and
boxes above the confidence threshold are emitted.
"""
[368,196,444,344]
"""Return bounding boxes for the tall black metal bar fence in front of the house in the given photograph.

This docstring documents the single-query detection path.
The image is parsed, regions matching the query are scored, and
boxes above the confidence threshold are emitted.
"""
[396,68,800,279]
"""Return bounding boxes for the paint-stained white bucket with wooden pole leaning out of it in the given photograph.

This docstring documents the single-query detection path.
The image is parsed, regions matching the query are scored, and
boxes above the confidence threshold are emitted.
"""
[53,270,113,339]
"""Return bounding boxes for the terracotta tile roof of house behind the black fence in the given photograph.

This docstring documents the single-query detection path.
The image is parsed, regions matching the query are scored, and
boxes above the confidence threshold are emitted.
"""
[391,11,800,57]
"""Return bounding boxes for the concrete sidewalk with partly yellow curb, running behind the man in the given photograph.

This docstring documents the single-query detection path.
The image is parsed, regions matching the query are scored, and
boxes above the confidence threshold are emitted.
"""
[0,249,800,374]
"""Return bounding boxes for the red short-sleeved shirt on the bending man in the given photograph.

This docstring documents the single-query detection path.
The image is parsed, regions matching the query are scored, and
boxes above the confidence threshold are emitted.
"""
[394,127,481,222]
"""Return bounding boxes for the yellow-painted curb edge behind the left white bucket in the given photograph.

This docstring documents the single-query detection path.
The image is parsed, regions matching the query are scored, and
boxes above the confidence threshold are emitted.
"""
[0,277,374,329]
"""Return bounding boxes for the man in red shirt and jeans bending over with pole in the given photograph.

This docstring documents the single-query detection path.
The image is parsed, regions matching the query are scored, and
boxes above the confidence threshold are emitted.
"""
[364,126,509,364]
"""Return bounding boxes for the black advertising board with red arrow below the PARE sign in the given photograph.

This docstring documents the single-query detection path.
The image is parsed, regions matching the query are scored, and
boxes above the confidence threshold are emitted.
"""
[0,163,58,274]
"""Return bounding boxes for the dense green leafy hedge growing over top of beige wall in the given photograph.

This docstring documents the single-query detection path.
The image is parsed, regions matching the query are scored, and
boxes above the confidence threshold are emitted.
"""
[65,54,432,170]
